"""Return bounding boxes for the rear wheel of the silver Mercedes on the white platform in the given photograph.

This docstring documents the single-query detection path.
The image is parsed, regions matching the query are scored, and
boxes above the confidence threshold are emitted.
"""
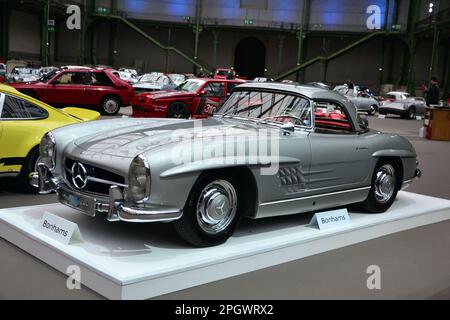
[361,161,401,213]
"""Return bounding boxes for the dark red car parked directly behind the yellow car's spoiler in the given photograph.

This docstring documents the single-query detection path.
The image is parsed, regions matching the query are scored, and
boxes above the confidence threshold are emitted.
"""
[10,68,134,115]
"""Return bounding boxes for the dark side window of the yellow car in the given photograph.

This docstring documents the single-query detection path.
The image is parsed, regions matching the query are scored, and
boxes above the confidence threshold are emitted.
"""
[1,96,48,119]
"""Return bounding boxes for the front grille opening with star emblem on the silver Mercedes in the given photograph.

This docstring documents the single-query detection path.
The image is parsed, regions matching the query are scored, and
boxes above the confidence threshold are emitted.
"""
[65,159,126,195]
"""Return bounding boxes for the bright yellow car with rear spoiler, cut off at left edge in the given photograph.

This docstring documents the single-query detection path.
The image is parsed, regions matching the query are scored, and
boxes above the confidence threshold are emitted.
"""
[0,84,100,190]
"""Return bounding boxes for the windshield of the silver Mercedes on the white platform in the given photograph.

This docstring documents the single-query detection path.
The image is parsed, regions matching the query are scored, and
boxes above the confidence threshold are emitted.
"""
[217,91,311,126]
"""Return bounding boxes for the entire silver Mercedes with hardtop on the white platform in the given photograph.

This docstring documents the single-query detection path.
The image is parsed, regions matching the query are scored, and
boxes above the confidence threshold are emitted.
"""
[38,83,421,246]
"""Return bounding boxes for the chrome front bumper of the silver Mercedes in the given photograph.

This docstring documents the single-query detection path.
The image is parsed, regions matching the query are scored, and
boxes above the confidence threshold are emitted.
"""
[38,163,182,222]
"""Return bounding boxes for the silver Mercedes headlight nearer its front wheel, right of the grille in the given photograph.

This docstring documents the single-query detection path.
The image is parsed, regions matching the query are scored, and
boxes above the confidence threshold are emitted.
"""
[127,156,150,202]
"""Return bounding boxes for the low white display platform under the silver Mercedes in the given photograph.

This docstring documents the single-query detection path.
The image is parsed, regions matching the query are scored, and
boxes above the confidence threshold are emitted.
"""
[0,192,450,299]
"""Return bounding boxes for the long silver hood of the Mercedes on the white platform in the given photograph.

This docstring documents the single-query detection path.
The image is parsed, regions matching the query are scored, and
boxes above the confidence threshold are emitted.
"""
[74,117,280,158]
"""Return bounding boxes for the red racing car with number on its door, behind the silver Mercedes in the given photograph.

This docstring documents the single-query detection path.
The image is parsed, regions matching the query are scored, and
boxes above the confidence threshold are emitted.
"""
[131,79,245,119]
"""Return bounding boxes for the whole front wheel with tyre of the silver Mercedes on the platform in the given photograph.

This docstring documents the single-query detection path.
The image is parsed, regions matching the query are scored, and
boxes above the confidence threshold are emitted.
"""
[174,174,240,247]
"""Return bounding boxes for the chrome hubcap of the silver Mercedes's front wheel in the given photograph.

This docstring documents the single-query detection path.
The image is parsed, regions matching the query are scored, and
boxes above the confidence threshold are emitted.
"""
[197,180,237,234]
